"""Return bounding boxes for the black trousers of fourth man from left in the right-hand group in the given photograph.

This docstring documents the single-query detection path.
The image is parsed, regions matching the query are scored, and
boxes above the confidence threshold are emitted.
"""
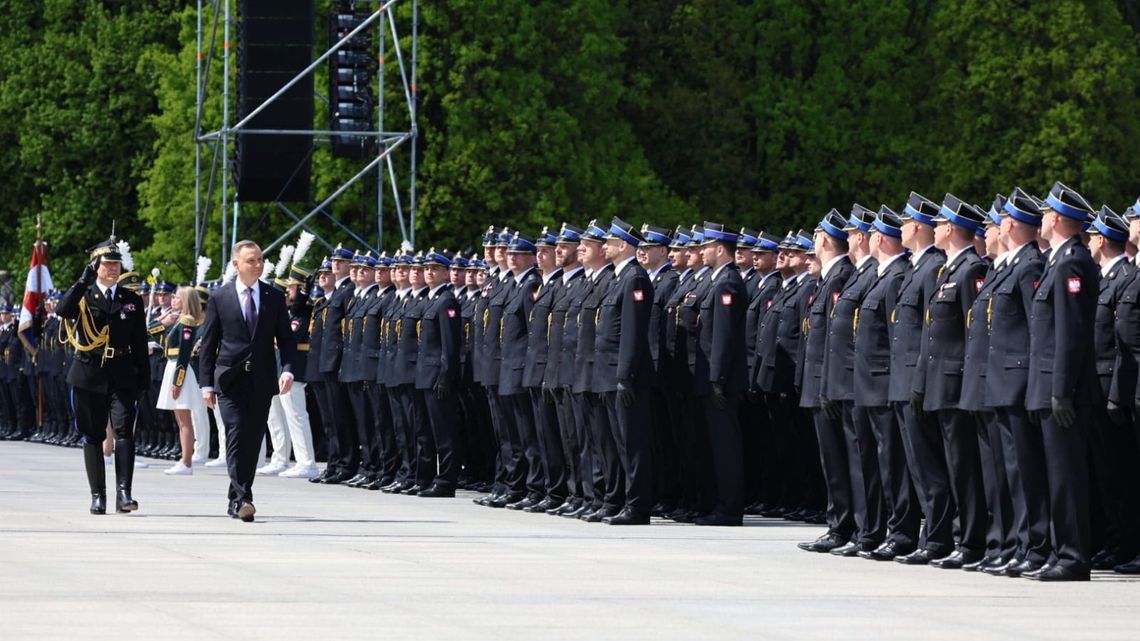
[894,403,954,555]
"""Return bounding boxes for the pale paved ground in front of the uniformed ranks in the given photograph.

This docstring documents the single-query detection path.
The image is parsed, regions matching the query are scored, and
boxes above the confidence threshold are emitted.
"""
[0,443,1140,641]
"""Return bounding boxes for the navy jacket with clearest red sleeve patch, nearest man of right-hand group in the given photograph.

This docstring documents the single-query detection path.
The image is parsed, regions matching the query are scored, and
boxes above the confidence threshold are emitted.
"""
[1025,237,1101,411]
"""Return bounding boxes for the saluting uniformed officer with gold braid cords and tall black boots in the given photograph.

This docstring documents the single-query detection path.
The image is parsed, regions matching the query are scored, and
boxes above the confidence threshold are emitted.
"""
[57,237,150,514]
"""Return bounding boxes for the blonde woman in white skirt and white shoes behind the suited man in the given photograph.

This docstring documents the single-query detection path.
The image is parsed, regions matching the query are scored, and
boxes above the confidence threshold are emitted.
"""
[156,286,205,476]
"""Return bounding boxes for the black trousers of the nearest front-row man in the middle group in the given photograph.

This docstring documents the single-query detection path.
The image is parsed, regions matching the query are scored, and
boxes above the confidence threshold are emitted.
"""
[602,386,653,516]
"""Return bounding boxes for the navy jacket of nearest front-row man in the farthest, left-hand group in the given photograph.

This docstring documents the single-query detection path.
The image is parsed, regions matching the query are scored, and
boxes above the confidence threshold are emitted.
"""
[415,284,463,390]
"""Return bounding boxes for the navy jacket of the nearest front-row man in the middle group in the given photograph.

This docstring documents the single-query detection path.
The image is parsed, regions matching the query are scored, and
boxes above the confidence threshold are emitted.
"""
[593,259,653,393]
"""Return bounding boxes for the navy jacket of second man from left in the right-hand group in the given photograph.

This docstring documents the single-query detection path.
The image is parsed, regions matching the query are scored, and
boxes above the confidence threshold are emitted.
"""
[822,257,879,400]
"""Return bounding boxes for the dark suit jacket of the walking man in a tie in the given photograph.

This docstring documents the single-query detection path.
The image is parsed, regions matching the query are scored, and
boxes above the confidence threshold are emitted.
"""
[200,282,296,400]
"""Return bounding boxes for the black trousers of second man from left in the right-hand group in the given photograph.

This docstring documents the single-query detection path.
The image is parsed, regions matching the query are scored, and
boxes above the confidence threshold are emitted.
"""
[839,400,887,540]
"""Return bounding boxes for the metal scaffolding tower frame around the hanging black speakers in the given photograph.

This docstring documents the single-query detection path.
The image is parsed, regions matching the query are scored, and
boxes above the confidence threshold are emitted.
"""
[194,0,420,265]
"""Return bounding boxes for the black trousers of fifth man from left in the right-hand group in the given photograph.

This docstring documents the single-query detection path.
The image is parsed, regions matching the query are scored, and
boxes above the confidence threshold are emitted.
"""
[938,409,986,554]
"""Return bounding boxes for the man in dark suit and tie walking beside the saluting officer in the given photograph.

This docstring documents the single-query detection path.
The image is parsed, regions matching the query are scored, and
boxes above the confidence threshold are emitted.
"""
[200,241,296,522]
